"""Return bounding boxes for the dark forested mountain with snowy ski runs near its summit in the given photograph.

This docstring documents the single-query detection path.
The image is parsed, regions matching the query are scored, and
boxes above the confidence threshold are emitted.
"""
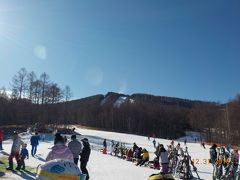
[0,92,240,145]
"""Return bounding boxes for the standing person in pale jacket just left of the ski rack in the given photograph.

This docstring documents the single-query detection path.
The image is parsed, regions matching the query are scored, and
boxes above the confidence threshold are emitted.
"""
[158,144,169,174]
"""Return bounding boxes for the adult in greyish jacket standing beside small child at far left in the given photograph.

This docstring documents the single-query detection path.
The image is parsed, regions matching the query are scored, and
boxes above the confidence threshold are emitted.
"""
[6,131,24,170]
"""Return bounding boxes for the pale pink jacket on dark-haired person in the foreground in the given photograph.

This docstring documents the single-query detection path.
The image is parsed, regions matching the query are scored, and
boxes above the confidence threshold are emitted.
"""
[46,144,73,161]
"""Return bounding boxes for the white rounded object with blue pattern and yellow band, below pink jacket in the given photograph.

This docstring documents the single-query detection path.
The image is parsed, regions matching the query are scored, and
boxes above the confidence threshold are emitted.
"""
[36,159,86,180]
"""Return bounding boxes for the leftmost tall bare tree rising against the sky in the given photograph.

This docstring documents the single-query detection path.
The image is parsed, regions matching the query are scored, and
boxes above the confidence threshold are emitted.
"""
[11,68,27,99]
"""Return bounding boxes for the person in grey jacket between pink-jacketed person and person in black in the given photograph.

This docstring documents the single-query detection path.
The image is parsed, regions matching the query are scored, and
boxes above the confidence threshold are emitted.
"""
[68,134,82,165]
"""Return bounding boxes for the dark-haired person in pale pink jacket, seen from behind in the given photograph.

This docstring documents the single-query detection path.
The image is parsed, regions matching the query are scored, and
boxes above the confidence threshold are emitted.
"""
[46,133,73,161]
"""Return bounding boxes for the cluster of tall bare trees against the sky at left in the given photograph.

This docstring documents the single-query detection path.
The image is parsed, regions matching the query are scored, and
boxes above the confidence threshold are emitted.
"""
[0,68,72,104]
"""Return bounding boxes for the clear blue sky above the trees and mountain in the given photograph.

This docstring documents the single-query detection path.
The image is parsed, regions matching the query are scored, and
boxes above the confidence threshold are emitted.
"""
[0,0,240,102]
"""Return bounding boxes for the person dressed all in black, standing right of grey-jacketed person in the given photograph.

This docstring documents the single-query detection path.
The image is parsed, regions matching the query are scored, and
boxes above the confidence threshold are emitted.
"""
[80,138,91,180]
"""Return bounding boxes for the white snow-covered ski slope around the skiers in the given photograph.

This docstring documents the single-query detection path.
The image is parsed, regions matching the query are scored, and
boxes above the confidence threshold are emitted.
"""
[0,128,212,180]
